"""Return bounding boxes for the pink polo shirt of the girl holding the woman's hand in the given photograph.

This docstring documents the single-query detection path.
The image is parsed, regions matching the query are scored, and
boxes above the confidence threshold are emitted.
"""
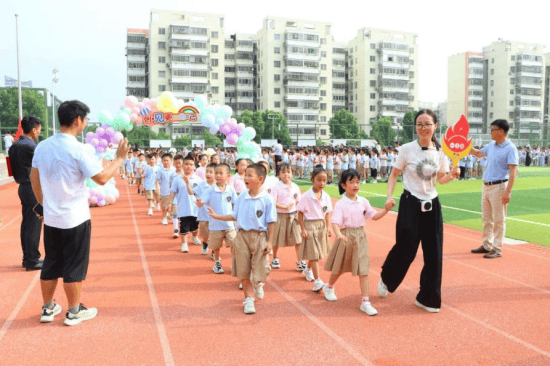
[332,194,376,229]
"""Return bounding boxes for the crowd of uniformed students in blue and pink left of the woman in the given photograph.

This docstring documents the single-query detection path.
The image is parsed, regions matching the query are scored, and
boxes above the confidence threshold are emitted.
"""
[120,148,393,315]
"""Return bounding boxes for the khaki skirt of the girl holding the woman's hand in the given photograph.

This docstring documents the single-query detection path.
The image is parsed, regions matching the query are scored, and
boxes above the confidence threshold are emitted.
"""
[325,227,370,276]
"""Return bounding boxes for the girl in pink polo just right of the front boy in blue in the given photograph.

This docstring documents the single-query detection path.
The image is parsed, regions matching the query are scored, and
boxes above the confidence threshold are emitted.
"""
[271,163,305,271]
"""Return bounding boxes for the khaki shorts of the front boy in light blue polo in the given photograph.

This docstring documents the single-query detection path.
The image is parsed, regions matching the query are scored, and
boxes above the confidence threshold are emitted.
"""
[233,230,271,282]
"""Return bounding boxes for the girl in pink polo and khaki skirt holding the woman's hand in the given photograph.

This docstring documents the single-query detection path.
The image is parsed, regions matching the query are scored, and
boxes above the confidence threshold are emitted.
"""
[323,169,389,315]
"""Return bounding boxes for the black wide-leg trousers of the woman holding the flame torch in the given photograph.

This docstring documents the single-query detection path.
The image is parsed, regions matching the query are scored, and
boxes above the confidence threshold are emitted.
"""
[382,190,443,308]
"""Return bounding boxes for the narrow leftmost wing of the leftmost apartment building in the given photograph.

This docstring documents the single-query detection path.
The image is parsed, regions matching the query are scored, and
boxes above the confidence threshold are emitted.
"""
[126,28,149,100]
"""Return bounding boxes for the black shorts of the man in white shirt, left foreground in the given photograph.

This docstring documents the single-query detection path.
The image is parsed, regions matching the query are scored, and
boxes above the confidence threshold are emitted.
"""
[40,220,92,283]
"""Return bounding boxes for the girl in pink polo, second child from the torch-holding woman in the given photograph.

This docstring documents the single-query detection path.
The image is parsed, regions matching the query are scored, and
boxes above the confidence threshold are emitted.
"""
[296,167,332,292]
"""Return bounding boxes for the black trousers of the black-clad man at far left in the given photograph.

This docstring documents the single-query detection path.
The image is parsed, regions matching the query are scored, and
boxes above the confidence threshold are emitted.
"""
[18,182,42,268]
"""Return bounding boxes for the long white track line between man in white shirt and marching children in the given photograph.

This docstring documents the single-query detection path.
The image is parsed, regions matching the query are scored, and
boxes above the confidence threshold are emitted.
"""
[126,186,175,366]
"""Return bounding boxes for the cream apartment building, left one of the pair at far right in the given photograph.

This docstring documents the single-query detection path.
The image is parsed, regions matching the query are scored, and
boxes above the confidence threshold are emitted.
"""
[447,52,487,134]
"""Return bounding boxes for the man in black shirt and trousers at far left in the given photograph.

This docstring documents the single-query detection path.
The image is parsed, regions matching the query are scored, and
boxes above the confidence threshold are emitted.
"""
[8,116,42,271]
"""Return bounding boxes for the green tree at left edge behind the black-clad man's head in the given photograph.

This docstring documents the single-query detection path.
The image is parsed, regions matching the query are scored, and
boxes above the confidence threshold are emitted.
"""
[0,88,49,136]
